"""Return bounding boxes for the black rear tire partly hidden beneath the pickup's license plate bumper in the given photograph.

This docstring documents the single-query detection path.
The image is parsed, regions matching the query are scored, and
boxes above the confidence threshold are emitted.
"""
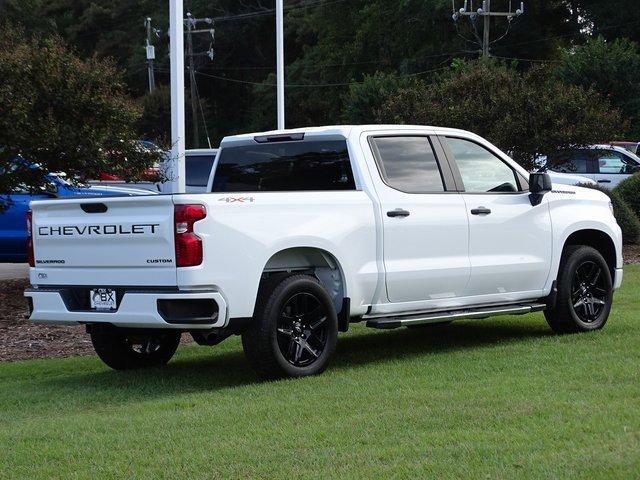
[91,329,181,370]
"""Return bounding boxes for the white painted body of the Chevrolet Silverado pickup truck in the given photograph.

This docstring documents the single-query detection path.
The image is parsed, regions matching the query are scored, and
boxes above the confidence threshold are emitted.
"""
[27,126,622,328]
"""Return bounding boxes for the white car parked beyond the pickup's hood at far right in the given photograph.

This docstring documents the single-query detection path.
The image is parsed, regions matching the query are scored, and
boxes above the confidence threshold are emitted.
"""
[545,145,640,188]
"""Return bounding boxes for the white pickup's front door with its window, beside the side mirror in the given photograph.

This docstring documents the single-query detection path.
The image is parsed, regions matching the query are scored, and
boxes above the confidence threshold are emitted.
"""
[444,137,552,302]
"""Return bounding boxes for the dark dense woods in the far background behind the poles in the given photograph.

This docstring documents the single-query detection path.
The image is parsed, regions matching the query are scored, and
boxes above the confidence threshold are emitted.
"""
[0,0,585,142]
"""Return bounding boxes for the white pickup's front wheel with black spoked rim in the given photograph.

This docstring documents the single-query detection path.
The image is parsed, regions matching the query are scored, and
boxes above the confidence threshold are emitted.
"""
[544,245,613,333]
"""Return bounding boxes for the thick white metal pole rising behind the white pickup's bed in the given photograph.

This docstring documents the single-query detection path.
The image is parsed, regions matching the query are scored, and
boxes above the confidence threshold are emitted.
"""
[167,0,186,193]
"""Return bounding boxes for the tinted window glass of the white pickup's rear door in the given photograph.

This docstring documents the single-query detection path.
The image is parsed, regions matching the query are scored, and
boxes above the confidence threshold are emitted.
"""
[373,137,444,193]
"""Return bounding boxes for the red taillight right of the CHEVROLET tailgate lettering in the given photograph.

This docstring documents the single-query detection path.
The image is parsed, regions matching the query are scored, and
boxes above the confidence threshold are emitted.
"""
[173,205,207,267]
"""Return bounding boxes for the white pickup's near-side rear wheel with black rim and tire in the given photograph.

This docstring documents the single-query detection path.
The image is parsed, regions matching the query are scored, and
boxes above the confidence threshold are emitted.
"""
[242,275,338,379]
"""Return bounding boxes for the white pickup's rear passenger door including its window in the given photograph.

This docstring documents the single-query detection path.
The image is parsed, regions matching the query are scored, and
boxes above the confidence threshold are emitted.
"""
[369,135,469,303]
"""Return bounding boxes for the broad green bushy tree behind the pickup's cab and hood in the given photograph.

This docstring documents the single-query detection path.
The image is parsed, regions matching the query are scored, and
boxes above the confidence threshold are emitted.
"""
[377,61,626,168]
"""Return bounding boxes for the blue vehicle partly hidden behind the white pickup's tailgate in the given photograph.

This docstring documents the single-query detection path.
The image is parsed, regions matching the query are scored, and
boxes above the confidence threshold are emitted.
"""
[0,174,154,263]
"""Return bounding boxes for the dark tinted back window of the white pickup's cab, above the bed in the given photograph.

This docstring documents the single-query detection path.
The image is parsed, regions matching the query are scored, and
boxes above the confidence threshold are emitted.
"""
[212,140,356,193]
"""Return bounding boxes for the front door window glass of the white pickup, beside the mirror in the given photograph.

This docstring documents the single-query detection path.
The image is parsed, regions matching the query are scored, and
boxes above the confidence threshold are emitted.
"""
[447,138,518,193]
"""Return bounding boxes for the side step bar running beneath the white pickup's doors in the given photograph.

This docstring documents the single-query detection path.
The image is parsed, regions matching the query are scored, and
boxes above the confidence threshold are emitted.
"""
[367,303,547,329]
